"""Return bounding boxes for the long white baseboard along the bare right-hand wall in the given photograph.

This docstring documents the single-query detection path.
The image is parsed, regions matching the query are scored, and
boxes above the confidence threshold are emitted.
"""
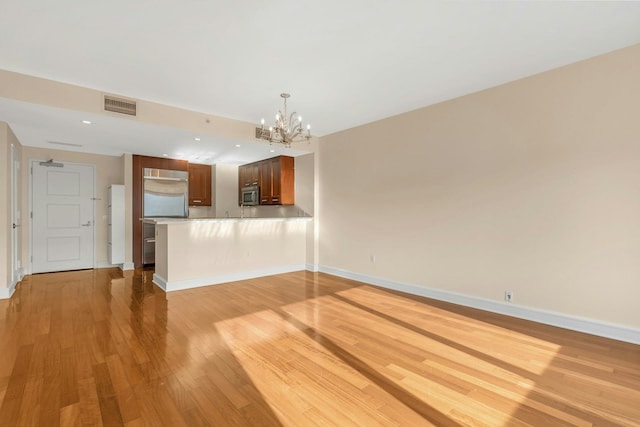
[319,265,640,344]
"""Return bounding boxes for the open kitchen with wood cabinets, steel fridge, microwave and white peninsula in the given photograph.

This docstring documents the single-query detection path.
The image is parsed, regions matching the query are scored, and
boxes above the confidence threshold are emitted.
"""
[131,154,314,291]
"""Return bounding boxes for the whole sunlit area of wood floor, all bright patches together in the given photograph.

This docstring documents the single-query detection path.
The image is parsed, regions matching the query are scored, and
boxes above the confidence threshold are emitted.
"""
[215,289,568,426]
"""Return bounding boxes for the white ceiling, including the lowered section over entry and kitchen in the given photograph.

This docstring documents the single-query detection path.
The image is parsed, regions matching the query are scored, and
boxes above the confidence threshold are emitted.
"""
[0,0,640,163]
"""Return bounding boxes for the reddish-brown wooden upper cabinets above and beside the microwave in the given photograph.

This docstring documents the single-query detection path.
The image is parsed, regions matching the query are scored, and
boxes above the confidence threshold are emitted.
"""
[238,156,295,205]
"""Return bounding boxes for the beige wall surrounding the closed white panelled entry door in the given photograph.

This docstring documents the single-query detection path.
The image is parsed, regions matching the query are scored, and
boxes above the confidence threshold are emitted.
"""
[22,147,124,267]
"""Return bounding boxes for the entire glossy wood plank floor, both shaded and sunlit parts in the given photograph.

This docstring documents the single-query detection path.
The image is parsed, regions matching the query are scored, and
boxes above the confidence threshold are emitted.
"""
[0,269,640,427]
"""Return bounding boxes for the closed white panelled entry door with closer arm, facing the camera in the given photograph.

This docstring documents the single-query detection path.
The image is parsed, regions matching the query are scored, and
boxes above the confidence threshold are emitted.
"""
[31,161,95,273]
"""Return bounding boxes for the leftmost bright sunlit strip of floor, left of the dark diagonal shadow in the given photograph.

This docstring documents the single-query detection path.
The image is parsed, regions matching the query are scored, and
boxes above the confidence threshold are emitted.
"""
[215,310,431,427]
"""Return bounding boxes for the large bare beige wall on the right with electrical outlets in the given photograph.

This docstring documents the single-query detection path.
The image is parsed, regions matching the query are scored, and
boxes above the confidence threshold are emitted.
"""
[320,45,640,328]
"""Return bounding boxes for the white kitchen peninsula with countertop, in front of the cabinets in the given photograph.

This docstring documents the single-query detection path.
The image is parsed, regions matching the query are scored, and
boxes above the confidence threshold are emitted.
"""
[144,216,312,292]
